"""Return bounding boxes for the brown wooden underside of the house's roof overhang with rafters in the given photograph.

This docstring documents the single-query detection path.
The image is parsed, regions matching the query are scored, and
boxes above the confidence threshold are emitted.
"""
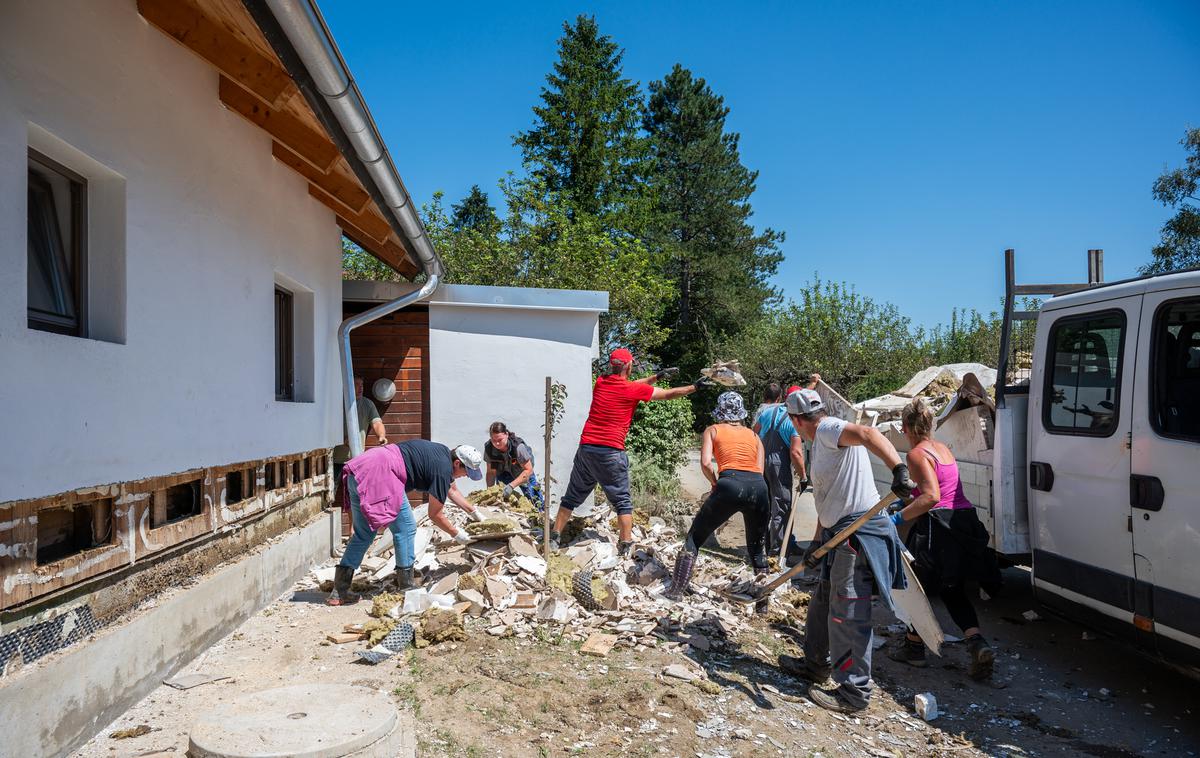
[137,0,436,278]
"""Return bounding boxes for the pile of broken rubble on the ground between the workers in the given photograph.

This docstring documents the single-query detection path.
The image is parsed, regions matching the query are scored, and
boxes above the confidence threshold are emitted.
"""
[308,488,786,676]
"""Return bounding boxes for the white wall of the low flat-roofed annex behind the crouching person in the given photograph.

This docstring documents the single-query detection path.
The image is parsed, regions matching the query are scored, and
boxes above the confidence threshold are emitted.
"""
[430,301,599,503]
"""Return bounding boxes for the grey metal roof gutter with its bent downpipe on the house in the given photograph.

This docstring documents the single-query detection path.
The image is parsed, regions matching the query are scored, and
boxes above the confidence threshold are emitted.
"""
[242,0,444,457]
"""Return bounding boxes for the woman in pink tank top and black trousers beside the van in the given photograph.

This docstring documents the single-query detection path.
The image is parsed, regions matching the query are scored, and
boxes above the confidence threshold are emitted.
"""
[888,399,1000,680]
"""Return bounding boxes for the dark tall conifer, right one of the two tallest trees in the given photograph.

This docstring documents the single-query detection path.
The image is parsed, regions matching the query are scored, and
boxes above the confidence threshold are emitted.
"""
[643,64,784,371]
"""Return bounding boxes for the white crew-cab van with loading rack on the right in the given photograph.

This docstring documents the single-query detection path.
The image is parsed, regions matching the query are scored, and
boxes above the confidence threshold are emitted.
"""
[872,251,1200,670]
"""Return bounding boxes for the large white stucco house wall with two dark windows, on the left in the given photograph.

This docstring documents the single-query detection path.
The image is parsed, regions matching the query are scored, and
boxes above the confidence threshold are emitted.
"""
[0,0,341,501]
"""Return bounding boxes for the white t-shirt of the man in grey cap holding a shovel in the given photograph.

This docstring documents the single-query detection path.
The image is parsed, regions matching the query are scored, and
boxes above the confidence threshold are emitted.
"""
[809,416,880,529]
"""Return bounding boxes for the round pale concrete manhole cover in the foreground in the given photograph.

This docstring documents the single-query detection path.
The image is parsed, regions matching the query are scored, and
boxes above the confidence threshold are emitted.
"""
[187,685,404,758]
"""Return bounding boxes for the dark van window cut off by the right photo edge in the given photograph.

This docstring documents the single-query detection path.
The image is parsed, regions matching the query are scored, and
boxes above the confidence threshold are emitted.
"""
[1150,297,1200,441]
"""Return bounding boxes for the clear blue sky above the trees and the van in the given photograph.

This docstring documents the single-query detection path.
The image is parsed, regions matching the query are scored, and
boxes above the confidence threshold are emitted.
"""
[322,0,1200,325]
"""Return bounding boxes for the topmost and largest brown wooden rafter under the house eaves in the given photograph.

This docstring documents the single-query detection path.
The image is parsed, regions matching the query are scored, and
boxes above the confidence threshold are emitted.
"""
[138,0,296,106]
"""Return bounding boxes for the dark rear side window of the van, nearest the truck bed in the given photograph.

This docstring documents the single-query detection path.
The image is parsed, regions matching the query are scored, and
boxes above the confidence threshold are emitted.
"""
[1042,311,1126,437]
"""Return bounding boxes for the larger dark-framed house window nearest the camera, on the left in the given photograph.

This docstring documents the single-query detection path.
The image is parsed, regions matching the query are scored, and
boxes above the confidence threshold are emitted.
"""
[28,150,88,337]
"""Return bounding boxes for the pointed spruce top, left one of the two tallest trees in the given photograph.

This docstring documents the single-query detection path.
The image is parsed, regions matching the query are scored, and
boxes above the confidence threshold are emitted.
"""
[512,16,646,221]
